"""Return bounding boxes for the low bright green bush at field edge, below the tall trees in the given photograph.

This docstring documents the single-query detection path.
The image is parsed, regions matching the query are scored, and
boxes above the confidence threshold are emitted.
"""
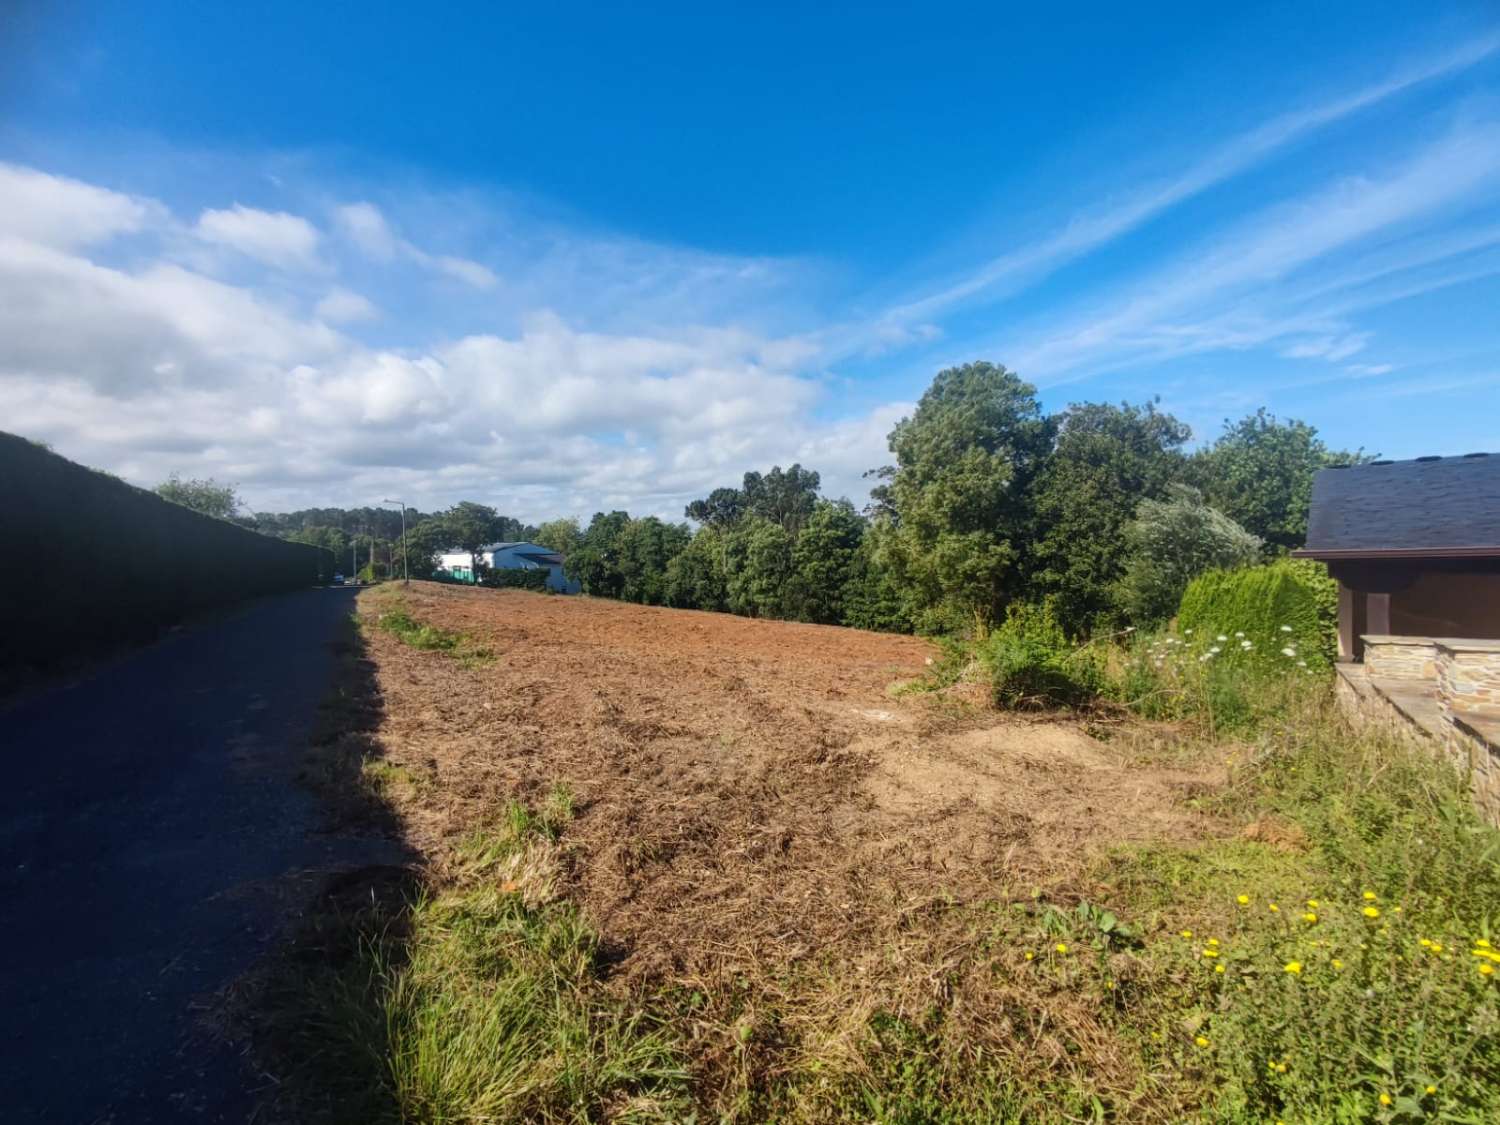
[978,605,1100,710]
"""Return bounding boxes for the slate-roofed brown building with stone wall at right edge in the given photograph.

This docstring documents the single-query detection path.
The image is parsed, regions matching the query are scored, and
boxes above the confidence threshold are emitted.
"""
[1295,453,1500,824]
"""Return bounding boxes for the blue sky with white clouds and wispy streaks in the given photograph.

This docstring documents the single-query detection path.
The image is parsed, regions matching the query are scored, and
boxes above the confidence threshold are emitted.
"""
[0,0,1500,519]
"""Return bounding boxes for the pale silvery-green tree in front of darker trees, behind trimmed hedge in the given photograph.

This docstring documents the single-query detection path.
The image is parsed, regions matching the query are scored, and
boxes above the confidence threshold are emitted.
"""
[1119,485,1262,624]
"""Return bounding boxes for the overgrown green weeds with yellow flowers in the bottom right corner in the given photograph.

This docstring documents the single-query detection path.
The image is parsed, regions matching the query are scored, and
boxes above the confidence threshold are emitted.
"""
[1098,696,1500,1124]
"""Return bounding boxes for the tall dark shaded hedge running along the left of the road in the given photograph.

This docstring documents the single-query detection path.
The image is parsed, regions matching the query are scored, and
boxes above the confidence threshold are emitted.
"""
[0,434,335,683]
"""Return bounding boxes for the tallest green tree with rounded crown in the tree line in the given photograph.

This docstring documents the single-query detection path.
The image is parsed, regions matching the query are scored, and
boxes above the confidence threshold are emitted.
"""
[876,363,1053,629]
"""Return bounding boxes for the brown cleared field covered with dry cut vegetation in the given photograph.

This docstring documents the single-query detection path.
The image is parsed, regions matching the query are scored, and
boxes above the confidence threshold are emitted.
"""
[351,584,1215,984]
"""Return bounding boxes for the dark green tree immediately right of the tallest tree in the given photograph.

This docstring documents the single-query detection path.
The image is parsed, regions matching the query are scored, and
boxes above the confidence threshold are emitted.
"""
[1029,402,1191,636]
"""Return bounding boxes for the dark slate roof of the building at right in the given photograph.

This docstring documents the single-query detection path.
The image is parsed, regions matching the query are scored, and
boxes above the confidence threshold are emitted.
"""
[1296,453,1500,558]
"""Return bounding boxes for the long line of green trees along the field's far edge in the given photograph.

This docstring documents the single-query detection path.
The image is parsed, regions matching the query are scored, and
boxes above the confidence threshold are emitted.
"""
[159,363,1365,636]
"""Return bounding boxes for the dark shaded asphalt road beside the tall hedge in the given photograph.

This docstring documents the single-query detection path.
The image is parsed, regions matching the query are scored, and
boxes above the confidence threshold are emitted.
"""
[0,590,392,1125]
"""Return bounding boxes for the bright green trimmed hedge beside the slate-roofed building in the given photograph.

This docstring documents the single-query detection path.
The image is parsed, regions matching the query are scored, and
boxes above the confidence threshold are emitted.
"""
[1178,560,1338,666]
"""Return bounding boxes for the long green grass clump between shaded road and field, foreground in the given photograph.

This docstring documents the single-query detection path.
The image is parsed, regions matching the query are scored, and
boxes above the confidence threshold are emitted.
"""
[259,789,692,1125]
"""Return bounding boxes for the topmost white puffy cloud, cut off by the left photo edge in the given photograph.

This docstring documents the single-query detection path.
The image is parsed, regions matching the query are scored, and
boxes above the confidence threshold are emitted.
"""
[0,164,159,249]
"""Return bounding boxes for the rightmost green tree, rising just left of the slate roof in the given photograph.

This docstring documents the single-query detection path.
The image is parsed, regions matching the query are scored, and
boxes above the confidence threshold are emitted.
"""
[1190,407,1368,555]
